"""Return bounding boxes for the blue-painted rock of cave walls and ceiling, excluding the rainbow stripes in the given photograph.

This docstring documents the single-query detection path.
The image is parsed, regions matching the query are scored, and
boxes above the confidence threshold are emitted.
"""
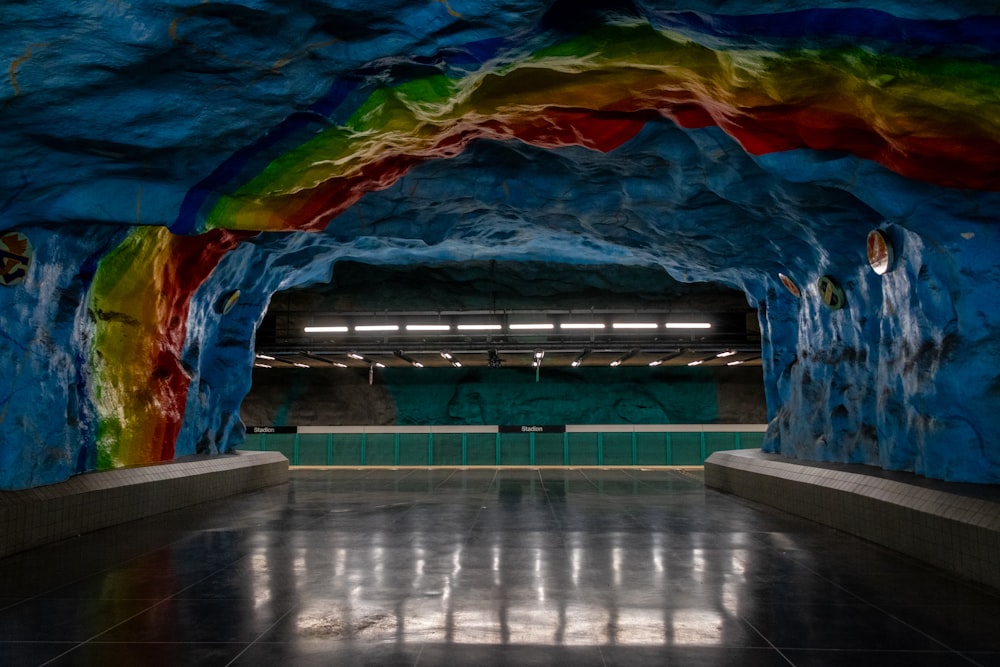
[0,0,1000,489]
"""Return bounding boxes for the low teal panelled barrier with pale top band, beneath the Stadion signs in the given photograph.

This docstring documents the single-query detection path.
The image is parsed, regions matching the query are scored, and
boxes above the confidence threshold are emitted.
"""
[239,424,767,467]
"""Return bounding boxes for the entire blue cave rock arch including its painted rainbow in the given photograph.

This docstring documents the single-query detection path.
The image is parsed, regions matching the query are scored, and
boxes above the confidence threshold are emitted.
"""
[0,0,1000,489]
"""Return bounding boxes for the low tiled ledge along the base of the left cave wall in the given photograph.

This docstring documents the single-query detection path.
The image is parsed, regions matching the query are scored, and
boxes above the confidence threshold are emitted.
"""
[0,452,288,557]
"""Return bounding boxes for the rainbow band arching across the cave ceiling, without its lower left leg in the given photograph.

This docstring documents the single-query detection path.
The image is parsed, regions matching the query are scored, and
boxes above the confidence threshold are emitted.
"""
[174,16,1000,233]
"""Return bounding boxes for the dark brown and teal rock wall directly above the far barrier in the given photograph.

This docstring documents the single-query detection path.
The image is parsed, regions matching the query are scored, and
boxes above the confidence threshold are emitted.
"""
[241,366,766,426]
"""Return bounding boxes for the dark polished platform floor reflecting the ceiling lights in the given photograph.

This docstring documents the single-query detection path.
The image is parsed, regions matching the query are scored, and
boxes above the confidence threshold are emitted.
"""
[0,469,1000,667]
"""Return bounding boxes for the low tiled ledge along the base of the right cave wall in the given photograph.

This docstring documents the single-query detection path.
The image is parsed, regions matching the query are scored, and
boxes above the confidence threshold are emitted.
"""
[705,450,1000,589]
